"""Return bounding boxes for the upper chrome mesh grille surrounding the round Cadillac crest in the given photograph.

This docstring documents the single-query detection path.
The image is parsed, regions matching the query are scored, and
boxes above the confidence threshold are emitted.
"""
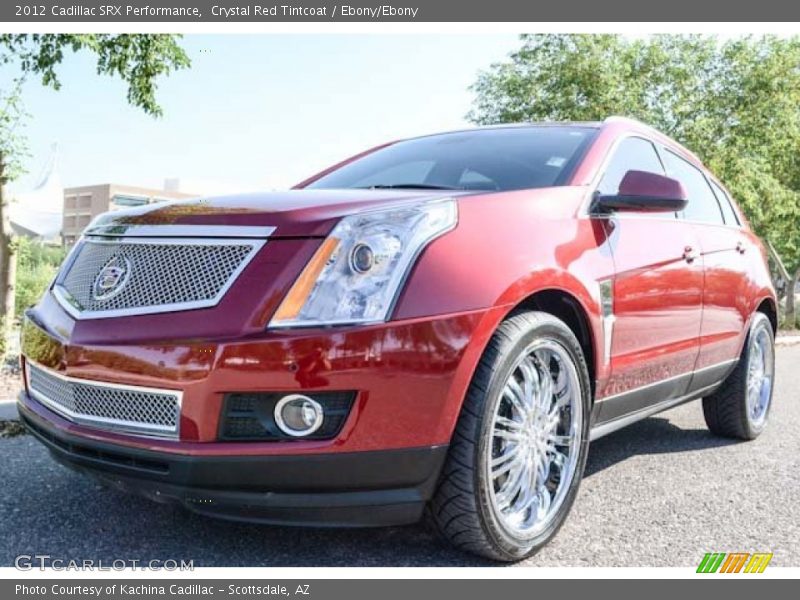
[58,239,260,316]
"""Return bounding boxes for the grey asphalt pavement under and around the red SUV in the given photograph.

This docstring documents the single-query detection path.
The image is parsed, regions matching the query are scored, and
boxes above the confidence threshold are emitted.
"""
[0,345,800,566]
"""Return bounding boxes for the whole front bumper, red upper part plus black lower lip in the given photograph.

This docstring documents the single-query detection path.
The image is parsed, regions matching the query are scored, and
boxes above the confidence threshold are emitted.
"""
[18,295,505,526]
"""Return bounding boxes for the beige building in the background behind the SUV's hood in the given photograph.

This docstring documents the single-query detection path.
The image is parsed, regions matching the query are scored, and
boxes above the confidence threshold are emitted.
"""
[62,183,197,245]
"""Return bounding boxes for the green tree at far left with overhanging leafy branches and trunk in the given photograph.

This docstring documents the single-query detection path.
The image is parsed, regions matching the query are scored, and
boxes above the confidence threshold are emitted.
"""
[0,34,190,352]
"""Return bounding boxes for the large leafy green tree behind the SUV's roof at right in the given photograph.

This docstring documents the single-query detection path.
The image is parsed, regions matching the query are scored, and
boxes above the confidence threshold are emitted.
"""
[468,34,800,324]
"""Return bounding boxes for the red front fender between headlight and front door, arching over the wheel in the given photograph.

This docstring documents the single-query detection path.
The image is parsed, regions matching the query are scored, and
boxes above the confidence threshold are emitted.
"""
[393,187,614,440]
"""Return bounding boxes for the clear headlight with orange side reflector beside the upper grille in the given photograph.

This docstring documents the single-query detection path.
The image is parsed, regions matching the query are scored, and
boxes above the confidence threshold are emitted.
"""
[270,199,457,327]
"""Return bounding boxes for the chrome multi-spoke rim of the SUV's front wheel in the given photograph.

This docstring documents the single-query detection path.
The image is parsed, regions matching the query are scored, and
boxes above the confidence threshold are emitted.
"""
[486,340,584,538]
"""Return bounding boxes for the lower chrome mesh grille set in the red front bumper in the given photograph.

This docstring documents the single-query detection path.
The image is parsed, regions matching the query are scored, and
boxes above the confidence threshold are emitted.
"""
[27,362,180,437]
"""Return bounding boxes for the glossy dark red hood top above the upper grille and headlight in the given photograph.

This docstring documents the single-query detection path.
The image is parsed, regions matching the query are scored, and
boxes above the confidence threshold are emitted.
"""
[86,190,464,237]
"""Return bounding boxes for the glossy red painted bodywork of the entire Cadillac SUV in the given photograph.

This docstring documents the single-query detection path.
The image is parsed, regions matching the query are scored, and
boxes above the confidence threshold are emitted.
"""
[18,120,775,464]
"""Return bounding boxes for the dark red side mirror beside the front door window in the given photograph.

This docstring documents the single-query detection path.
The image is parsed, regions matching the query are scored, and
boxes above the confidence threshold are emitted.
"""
[591,171,688,214]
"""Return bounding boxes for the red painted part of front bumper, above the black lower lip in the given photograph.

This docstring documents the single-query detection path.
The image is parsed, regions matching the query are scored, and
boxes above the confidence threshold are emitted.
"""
[24,310,497,455]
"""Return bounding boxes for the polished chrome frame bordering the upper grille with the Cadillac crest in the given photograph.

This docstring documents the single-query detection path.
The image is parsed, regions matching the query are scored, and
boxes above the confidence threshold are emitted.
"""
[50,234,267,320]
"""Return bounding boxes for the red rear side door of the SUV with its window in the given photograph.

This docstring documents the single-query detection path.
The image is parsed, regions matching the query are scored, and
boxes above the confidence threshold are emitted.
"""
[663,150,750,392]
